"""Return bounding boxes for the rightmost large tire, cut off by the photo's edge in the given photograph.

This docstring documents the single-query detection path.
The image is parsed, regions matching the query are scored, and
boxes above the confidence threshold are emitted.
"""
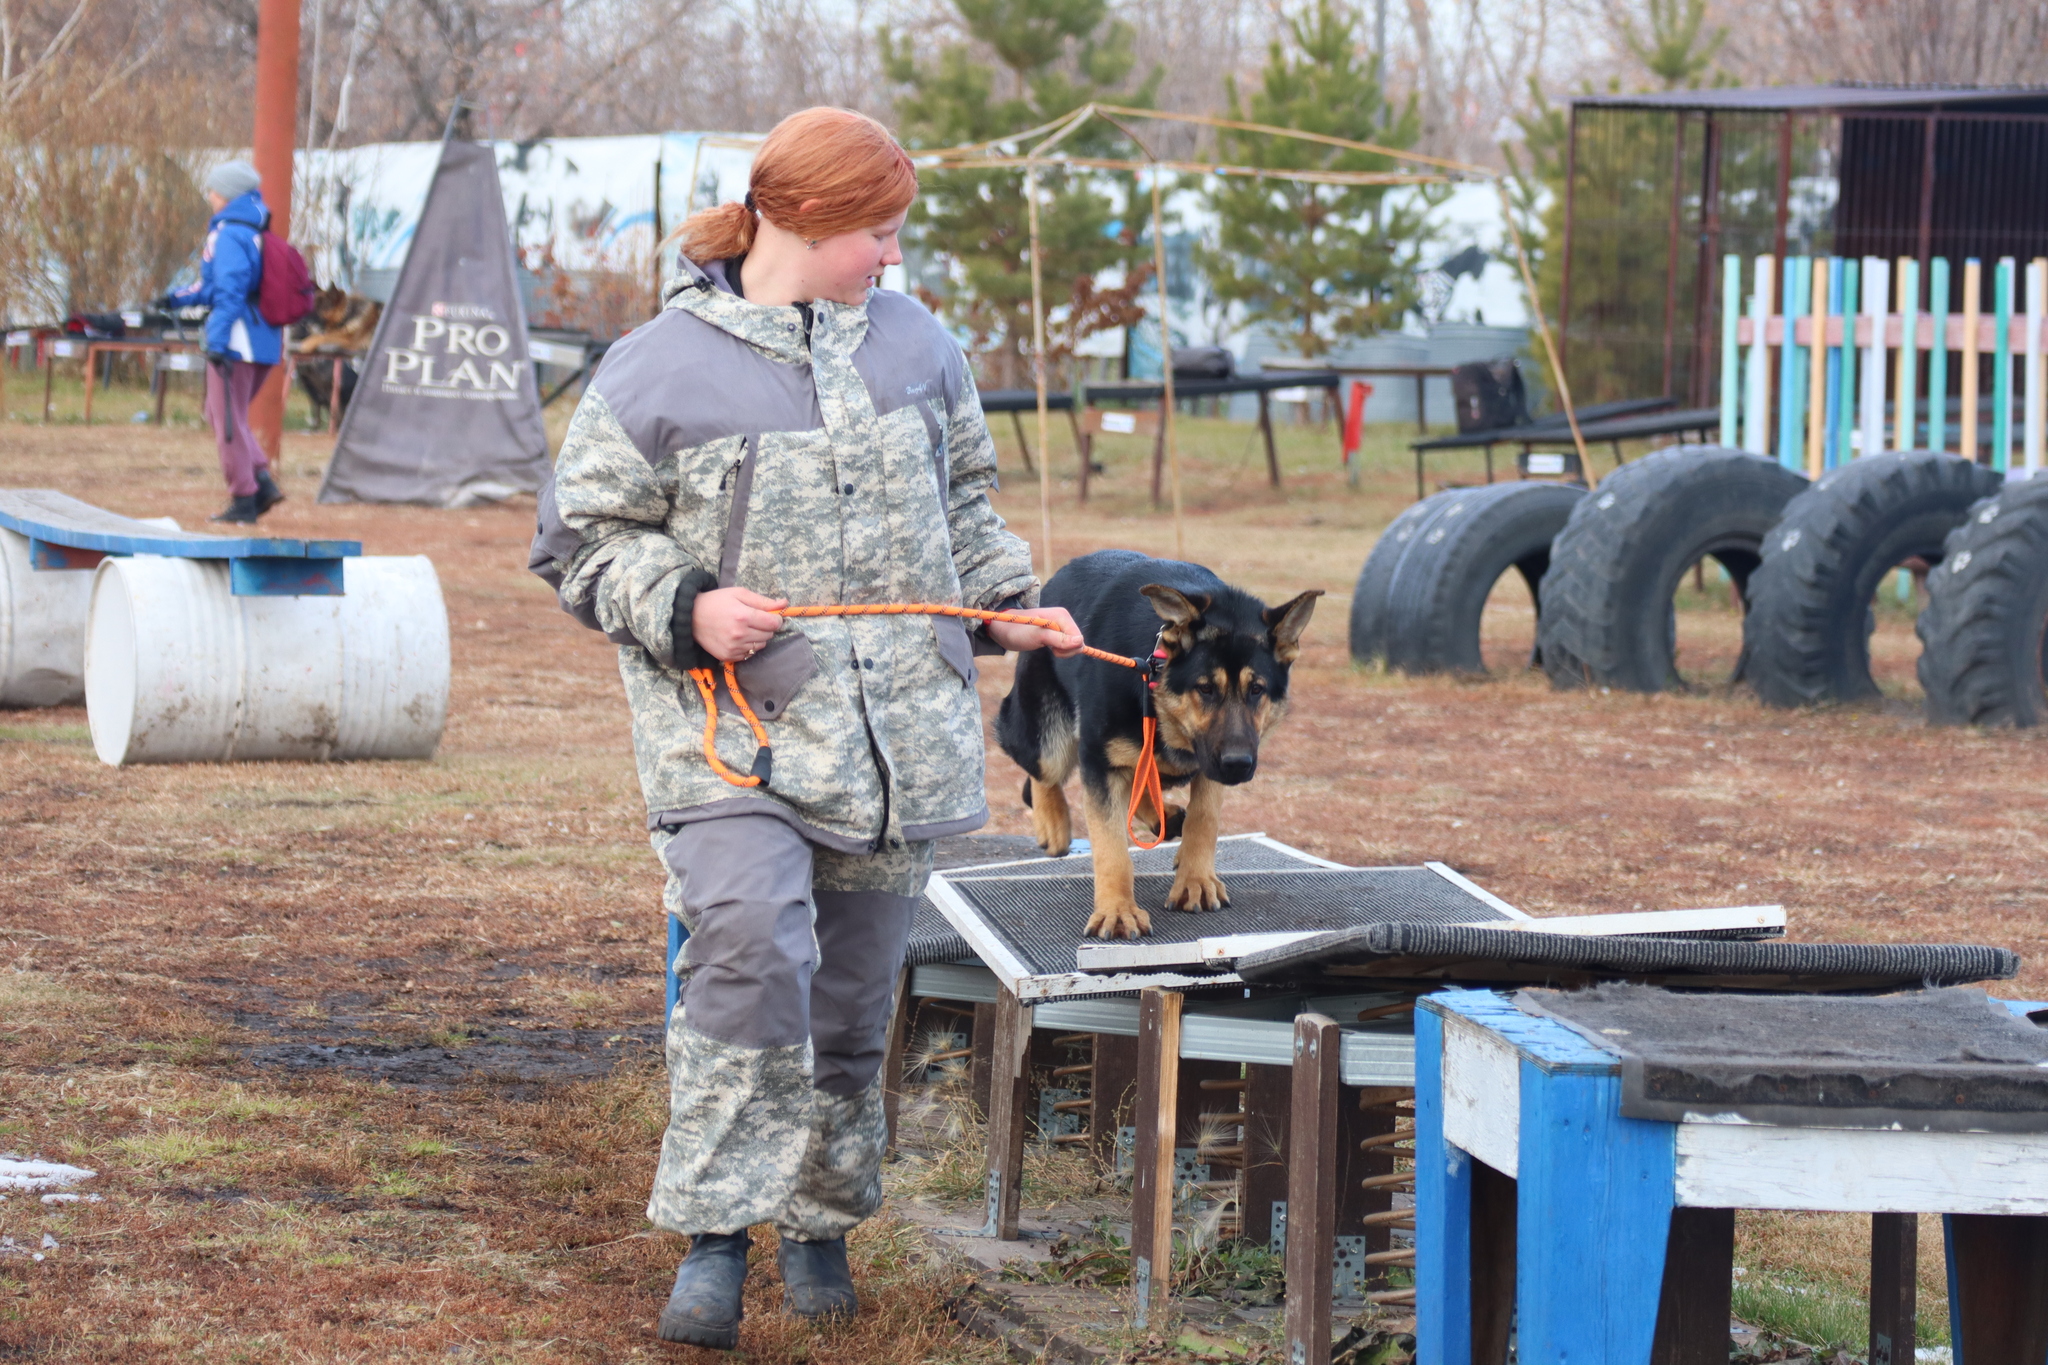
[1917,479,2048,726]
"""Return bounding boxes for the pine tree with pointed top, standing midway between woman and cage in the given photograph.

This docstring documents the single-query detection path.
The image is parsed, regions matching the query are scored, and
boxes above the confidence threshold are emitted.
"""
[1196,0,1436,356]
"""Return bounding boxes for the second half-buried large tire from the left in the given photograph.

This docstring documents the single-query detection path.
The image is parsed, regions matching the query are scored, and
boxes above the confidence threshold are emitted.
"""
[1536,446,1806,692]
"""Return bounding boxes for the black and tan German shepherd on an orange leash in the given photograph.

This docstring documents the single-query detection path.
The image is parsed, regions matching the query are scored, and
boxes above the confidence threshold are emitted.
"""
[995,551,1323,939]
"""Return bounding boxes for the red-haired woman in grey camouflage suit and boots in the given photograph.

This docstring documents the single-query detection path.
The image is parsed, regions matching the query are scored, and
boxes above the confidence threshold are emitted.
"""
[532,108,1081,1349]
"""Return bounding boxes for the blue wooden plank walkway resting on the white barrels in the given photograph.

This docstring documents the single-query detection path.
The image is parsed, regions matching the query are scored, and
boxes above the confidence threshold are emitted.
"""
[0,489,362,598]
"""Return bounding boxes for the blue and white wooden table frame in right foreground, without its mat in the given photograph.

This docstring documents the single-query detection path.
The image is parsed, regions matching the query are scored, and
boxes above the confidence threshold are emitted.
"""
[1415,990,2048,1365]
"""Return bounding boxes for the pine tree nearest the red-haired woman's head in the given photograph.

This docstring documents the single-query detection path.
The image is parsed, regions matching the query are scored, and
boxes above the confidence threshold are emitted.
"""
[883,0,1159,387]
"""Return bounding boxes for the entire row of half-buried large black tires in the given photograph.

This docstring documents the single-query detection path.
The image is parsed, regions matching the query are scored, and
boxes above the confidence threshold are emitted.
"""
[1352,446,2048,724]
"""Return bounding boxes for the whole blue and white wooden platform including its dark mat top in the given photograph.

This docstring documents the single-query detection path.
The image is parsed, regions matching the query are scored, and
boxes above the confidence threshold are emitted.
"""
[1415,986,2048,1365]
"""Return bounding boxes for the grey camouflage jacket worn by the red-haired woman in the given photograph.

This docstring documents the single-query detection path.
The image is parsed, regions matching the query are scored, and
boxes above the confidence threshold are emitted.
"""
[530,262,1036,851]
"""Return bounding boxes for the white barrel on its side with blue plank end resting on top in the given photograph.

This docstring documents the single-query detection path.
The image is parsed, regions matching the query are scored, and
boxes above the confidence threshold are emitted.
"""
[86,555,449,763]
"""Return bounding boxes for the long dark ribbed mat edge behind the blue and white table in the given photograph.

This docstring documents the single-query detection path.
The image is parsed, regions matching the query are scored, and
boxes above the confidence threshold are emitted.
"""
[1237,923,2019,993]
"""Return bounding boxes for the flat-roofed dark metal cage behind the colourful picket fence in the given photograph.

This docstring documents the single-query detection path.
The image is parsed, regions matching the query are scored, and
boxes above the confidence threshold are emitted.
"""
[1559,86,2048,405]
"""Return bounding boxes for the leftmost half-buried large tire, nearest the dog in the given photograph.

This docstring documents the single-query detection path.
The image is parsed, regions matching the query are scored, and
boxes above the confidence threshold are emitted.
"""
[1352,483,1585,673]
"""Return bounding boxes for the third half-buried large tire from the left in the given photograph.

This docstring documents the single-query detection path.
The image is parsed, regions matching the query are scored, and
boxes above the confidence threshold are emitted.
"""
[1743,450,2001,706]
